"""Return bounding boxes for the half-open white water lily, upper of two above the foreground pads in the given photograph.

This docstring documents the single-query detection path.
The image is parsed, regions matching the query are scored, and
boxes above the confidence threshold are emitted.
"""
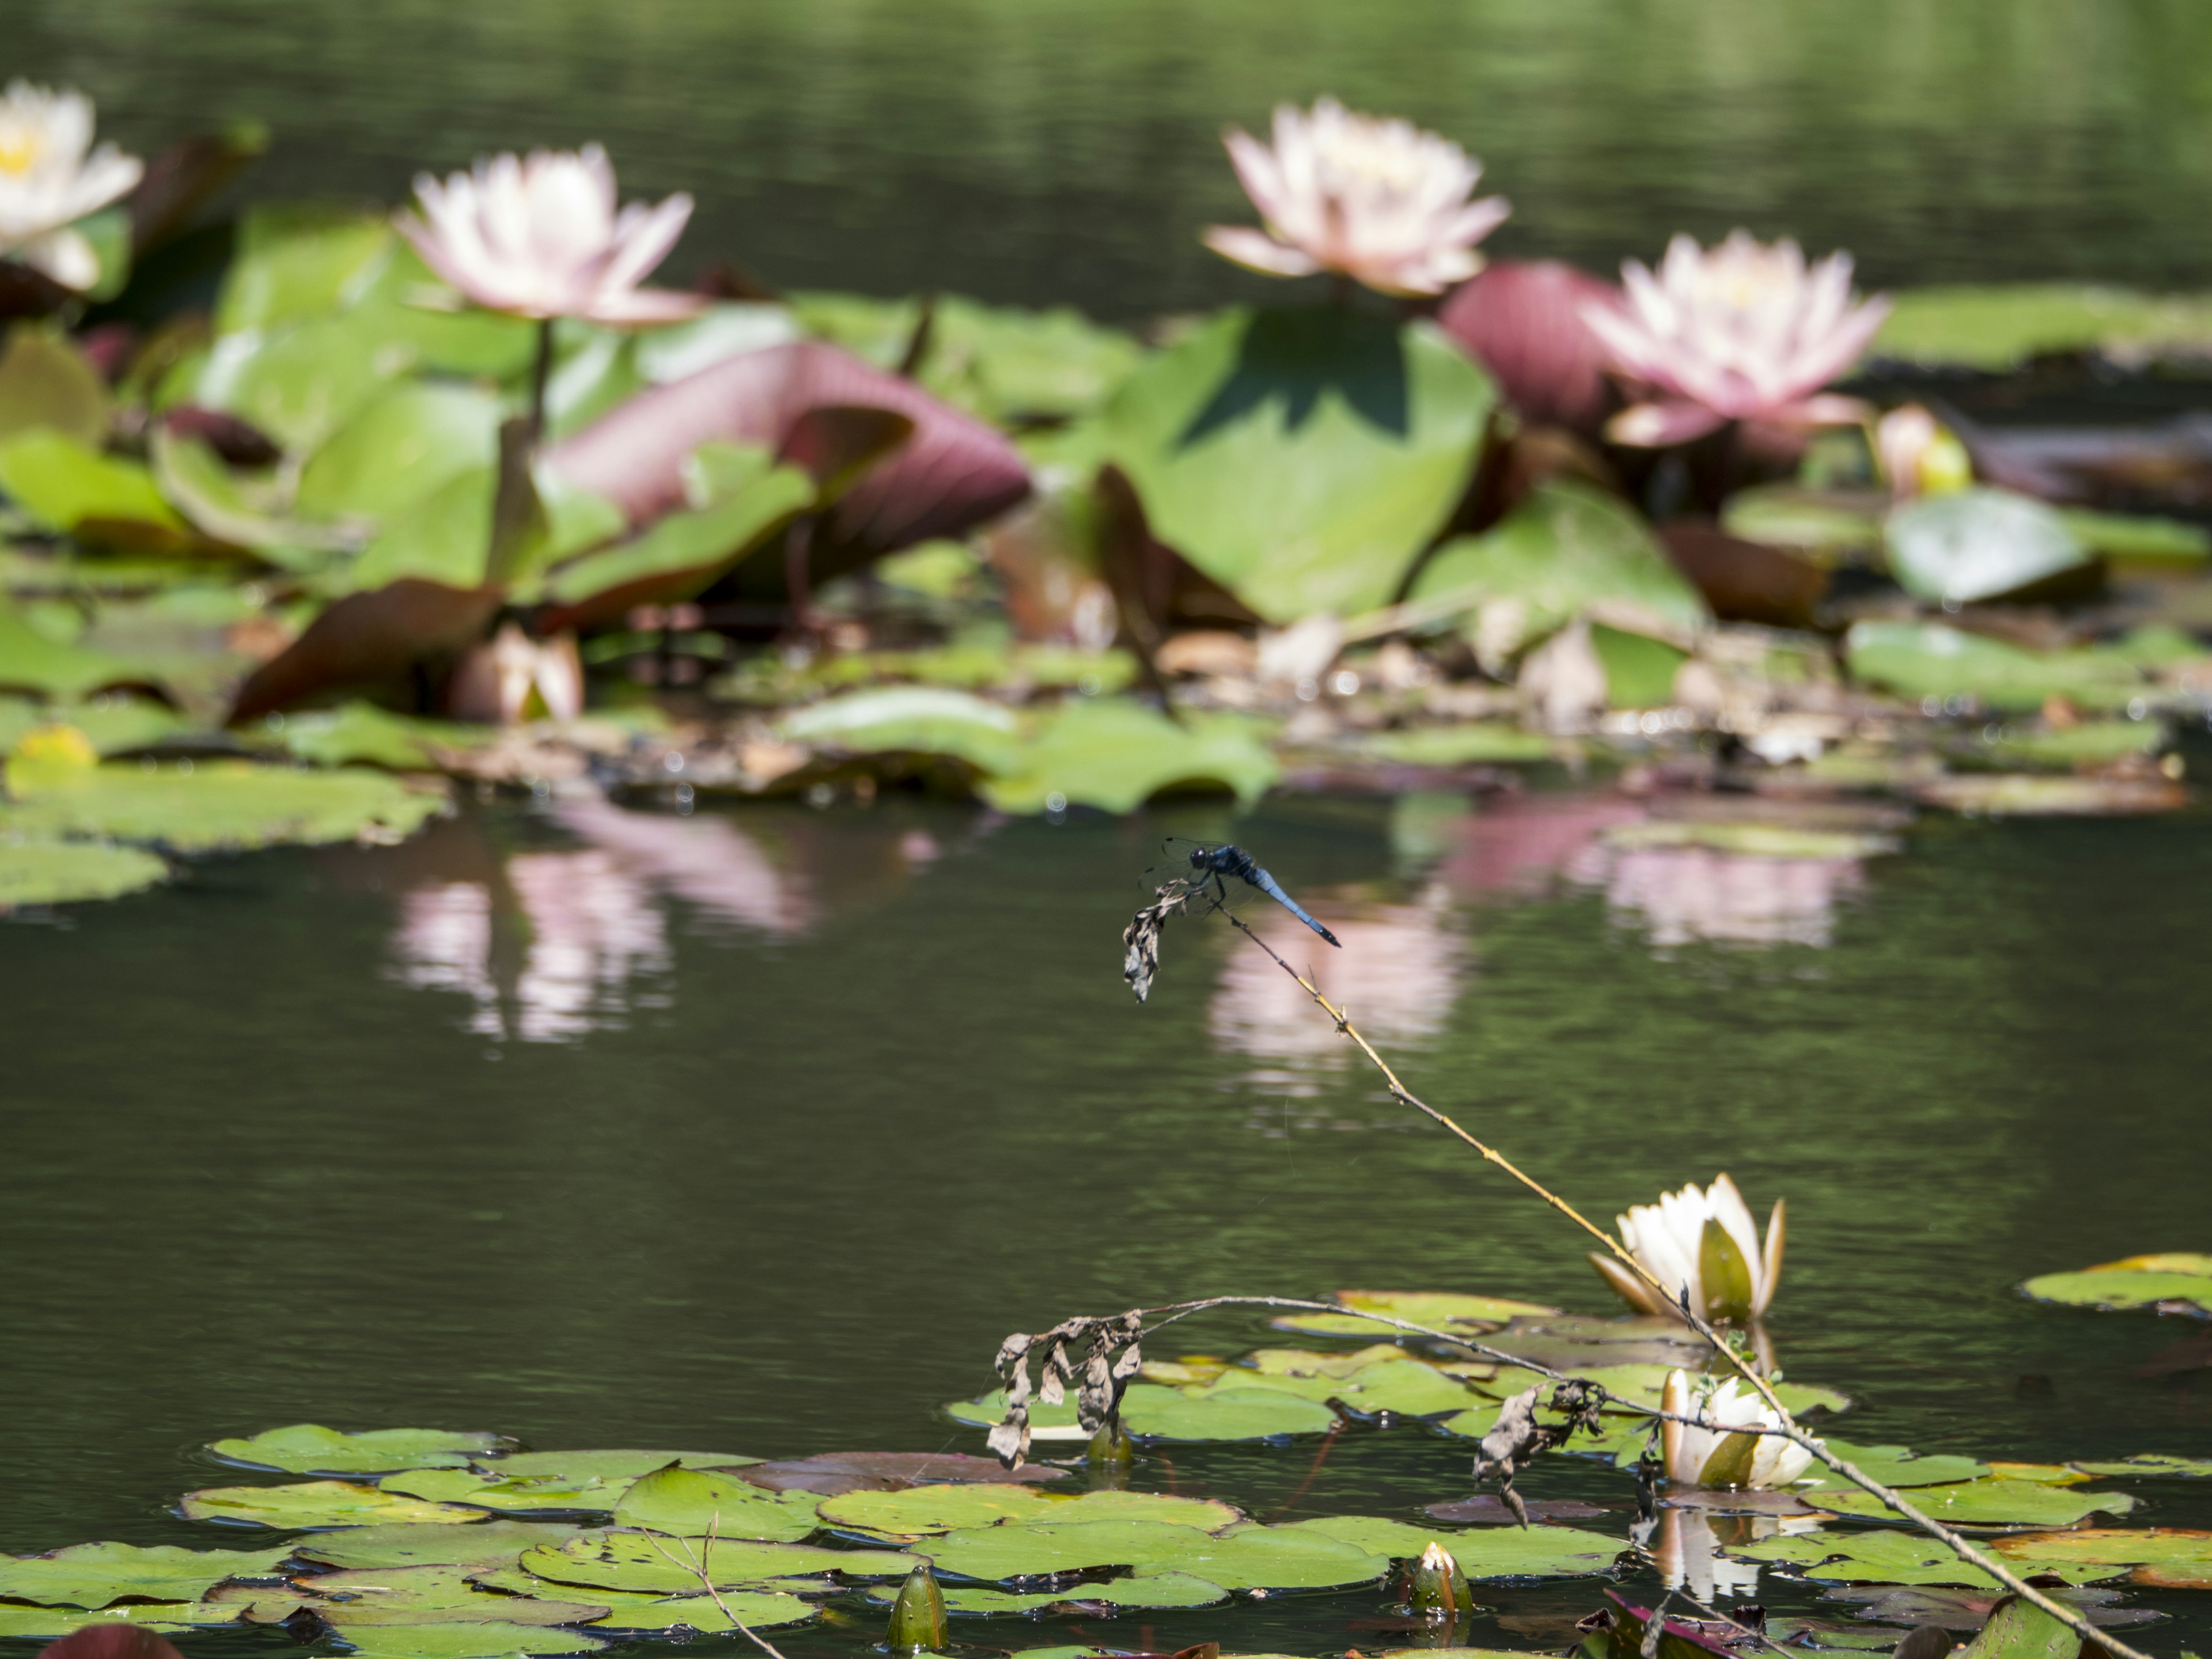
[1590,1175,1787,1325]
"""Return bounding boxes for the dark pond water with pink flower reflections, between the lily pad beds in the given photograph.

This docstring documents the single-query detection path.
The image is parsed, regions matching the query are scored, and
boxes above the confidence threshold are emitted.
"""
[0,790,2212,1654]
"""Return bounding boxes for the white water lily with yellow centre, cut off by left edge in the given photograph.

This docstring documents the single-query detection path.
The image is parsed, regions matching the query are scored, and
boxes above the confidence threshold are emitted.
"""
[0,79,146,292]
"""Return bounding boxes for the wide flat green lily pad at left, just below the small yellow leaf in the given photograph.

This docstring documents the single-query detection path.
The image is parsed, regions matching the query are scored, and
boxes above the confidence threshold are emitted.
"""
[0,761,445,851]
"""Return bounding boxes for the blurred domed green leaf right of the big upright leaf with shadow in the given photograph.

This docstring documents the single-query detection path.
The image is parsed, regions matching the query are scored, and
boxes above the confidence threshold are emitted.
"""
[1411,482,1712,650]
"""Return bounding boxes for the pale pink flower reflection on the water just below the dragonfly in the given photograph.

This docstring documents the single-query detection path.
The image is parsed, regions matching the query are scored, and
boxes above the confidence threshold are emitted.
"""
[1208,893,1462,1095]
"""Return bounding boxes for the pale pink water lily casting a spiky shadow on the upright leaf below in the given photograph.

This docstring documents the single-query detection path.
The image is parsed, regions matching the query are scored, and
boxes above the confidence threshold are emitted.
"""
[1206,97,1511,294]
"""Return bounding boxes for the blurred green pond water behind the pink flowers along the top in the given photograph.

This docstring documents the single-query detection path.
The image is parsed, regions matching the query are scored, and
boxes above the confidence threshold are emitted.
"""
[13,0,2212,319]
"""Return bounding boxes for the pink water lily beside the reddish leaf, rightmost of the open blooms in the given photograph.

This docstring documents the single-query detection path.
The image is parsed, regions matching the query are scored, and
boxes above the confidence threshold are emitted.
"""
[1582,230,1889,447]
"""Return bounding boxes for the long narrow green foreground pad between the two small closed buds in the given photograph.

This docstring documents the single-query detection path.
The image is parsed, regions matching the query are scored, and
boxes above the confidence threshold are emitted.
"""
[916,1520,1389,1590]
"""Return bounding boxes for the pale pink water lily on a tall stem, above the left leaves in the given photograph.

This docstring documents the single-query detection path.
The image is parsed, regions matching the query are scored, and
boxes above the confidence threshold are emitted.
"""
[398,144,706,325]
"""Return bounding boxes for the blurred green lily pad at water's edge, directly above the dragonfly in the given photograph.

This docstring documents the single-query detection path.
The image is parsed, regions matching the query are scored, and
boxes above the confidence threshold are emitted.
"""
[982,697,1279,812]
